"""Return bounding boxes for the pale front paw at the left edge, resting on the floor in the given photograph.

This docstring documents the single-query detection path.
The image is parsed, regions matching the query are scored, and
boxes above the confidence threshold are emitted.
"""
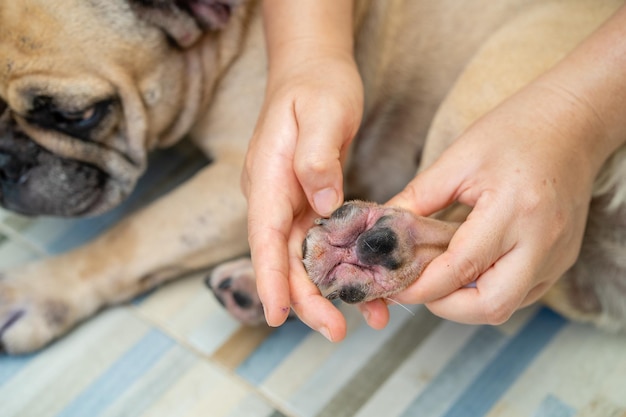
[0,277,76,354]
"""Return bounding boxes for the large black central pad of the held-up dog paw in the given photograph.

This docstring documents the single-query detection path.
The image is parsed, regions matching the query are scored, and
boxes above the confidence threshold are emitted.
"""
[356,227,399,270]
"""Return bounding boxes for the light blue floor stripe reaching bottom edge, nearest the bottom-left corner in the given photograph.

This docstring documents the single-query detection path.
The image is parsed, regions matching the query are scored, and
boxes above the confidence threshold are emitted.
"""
[57,330,175,417]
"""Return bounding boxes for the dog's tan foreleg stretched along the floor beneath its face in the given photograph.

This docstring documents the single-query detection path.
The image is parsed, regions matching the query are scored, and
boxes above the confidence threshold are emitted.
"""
[0,161,247,353]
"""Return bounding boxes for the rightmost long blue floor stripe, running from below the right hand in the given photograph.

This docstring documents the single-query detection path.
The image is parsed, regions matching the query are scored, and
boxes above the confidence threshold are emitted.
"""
[438,308,567,417]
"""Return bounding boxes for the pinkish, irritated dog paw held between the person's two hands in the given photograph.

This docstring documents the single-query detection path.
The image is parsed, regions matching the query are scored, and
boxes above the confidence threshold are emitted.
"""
[302,201,458,303]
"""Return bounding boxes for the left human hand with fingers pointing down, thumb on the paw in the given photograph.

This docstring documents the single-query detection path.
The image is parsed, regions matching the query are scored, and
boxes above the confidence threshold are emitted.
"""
[242,47,363,340]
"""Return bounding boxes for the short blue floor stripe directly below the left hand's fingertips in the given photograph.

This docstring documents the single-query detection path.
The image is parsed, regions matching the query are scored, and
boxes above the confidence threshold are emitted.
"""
[235,320,311,385]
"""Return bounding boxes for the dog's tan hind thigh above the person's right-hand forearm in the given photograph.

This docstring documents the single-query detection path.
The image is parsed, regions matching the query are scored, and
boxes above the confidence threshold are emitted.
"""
[420,1,621,169]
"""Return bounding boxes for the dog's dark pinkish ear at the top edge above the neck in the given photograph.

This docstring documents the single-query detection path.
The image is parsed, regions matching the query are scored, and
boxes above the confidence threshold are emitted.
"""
[129,0,240,47]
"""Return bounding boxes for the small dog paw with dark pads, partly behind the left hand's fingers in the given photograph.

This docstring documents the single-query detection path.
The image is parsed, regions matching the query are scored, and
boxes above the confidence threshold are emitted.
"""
[205,258,265,326]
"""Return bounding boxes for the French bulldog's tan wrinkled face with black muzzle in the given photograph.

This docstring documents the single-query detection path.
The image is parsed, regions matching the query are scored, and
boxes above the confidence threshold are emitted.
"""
[0,0,193,216]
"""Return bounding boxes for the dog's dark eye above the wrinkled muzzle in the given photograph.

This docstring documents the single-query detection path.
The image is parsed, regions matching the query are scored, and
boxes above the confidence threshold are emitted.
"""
[28,97,112,139]
